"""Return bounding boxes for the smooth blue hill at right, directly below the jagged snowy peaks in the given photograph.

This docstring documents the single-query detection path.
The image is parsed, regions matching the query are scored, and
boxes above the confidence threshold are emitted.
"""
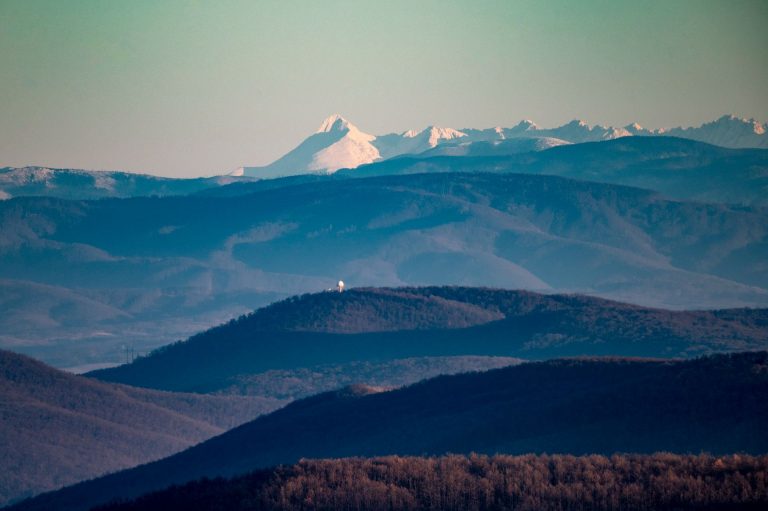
[352,137,768,205]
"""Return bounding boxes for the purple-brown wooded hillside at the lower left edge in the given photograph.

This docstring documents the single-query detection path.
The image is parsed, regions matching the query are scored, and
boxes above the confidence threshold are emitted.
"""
[0,351,283,505]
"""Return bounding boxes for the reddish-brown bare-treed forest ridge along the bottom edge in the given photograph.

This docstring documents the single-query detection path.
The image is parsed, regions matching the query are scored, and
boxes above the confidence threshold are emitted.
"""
[94,453,768,511]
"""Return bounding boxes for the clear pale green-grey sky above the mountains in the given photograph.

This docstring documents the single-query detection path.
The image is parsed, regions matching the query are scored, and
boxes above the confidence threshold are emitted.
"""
[0,0,768,177]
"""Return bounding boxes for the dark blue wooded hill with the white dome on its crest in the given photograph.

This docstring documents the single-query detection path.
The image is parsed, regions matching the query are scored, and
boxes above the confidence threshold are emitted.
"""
[90,288,768,397]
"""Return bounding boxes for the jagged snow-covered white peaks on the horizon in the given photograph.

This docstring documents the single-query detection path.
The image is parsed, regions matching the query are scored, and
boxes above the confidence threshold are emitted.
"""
[233,114,768,178]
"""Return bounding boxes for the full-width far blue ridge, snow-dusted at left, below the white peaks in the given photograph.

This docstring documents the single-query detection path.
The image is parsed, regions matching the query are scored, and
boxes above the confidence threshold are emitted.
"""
[0,136,768,209]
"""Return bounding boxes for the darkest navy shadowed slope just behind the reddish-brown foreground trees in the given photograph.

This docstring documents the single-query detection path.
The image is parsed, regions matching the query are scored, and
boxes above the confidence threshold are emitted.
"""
[14,352,768,511]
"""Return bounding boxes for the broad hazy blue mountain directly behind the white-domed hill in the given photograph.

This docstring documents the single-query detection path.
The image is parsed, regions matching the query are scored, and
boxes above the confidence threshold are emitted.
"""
[0,173,768,366]
